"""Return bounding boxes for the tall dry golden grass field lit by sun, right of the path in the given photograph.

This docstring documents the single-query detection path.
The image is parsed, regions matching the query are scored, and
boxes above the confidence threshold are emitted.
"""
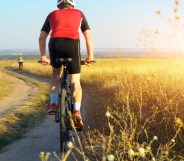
[2,58,184,161]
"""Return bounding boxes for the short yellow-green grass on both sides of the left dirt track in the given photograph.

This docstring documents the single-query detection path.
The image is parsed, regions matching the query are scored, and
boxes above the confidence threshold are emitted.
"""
[0,60,48,150]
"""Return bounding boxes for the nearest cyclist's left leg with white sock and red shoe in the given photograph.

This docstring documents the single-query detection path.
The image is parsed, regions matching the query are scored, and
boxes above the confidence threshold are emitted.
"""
[48,68,61,115]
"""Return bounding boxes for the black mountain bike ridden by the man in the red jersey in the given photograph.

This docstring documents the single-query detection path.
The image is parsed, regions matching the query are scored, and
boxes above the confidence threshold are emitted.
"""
[39,58,96,153]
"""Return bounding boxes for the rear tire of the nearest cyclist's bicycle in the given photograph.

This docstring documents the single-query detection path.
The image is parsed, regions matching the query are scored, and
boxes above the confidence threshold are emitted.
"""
[60,89,69,153]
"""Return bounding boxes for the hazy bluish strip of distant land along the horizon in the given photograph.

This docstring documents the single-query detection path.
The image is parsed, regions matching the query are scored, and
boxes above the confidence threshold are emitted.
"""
[0,48,184,60]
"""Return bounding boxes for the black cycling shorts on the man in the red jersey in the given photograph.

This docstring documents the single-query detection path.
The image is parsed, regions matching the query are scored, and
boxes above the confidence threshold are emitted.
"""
[49,38,81,74]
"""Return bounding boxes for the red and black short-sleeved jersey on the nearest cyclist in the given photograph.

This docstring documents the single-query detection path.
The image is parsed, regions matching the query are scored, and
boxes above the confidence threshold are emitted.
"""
[41,9,90,40]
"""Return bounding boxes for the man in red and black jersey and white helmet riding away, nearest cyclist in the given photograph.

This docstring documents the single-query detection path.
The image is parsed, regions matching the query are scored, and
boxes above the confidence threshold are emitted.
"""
[39,0,94,127]
